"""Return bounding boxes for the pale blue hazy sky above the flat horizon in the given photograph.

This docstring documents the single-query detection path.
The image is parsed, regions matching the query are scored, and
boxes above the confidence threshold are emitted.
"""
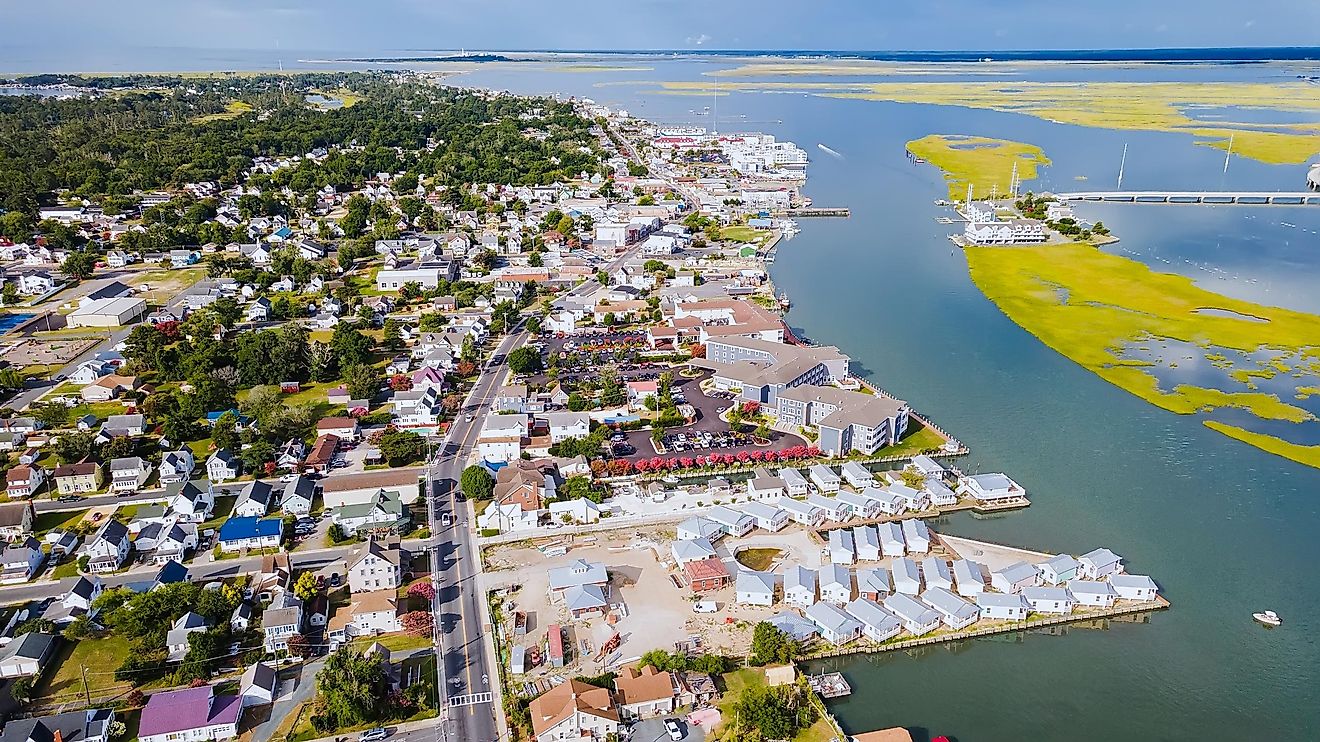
[0,0,1320,54]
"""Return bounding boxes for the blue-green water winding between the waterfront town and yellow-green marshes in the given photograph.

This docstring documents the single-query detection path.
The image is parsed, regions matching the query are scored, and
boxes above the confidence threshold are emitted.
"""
[443,62,1320,742]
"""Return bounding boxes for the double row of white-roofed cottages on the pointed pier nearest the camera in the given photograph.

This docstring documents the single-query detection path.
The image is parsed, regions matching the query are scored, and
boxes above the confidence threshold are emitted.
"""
[737,549,1159,644]
